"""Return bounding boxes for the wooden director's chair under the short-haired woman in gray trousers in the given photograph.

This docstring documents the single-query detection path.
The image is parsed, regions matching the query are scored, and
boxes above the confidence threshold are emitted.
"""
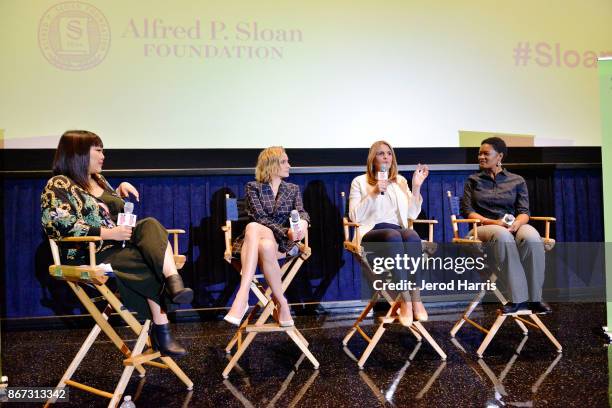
[446,191,562,357]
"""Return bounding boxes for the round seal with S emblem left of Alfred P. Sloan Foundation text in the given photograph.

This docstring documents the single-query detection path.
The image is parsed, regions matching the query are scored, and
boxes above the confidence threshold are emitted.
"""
[38,1,110,71]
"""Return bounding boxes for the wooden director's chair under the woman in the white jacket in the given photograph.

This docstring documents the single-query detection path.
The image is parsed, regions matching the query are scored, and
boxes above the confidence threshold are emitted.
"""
[341,192,446,369]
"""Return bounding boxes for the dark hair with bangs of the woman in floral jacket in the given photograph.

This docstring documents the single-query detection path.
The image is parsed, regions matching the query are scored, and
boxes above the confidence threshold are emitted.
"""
[53,130,104,191]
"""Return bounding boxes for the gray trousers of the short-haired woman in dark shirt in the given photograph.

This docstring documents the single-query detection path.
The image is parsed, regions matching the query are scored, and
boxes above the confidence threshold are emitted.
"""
[478,224,545,303]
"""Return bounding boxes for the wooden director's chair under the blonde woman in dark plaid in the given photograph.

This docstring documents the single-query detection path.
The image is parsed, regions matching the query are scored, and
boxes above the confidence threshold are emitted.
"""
[221,194,319,378]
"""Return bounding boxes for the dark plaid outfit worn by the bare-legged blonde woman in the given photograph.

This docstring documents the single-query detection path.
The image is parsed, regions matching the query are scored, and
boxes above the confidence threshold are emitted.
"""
[232,181,310,253]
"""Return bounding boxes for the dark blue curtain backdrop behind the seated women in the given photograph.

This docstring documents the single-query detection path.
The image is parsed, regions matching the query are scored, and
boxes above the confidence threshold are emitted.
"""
[0,169,603,317]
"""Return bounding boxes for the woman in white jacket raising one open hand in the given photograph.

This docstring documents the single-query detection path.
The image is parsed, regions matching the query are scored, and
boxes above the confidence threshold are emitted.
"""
[349,140,429,326]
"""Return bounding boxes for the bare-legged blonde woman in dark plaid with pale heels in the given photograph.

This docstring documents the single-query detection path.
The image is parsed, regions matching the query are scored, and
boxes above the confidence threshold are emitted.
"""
[224,146,309,326]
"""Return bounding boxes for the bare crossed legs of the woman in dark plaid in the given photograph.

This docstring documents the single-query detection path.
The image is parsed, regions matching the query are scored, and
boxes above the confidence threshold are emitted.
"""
[228,222,291,322]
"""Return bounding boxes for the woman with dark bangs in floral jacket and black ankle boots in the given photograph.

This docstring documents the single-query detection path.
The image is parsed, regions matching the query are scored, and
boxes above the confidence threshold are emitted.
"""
[41,130,193,357]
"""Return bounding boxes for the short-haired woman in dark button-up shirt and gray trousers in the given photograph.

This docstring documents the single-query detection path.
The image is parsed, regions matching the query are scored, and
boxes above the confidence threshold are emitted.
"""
[461,137,551,314]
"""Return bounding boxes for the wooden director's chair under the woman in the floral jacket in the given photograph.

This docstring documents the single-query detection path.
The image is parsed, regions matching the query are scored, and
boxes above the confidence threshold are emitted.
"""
[45,229,193,407]
